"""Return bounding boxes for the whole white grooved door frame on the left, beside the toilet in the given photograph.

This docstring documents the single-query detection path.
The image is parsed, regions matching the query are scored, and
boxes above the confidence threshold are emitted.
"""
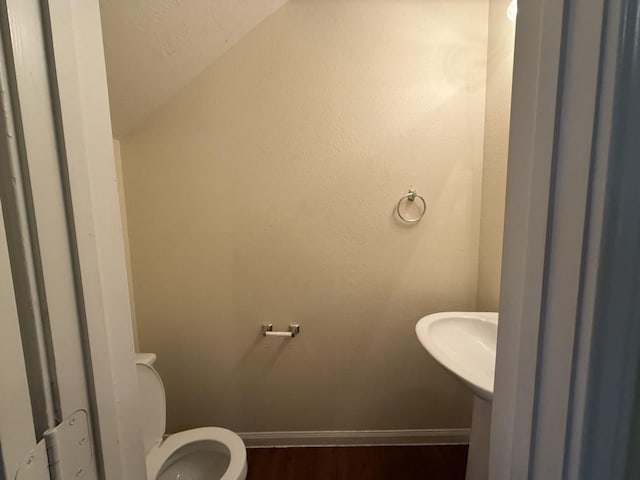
[0,0,146,480]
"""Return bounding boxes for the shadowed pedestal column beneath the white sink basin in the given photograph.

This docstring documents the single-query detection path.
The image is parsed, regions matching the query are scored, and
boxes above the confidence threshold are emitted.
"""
[465,395,491,480]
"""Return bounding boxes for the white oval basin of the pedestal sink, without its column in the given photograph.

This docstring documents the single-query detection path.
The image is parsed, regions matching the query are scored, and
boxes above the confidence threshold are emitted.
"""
[416,312,498,401]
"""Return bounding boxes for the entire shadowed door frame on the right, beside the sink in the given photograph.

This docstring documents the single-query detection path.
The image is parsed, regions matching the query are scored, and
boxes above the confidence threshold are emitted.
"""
[490,0,640,480]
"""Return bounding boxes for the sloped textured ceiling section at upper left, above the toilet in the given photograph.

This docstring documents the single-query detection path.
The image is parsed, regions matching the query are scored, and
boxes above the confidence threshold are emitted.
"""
[100,0,287,138]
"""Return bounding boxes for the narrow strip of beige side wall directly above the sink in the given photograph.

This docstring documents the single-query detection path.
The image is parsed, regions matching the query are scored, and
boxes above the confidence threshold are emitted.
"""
[478,0,515,312]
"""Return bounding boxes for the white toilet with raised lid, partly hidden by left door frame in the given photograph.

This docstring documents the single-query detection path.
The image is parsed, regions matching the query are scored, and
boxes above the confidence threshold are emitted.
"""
[136,353,247,480]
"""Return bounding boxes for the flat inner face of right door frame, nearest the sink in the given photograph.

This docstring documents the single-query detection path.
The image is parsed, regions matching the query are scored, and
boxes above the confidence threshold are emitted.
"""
[490,1,563,480]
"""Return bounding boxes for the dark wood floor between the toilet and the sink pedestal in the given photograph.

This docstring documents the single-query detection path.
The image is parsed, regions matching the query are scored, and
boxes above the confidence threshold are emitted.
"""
[247,445,467,480]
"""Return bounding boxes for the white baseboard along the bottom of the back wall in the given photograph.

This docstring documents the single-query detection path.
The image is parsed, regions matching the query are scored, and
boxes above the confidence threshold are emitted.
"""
[238,428,470,448]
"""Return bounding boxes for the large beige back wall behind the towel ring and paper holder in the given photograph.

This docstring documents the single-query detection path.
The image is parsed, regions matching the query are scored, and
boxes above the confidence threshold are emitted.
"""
[122,0,488,431]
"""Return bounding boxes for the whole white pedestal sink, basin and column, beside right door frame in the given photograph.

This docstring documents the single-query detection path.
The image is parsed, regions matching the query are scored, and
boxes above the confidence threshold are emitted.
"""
[416,312,498,480]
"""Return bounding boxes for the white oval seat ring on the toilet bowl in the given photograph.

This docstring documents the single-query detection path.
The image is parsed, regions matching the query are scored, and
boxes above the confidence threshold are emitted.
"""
[147,427,247,480]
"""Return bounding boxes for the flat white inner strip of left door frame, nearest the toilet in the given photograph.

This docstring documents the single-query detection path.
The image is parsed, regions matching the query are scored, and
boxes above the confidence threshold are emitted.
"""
[43,0,146,480]
